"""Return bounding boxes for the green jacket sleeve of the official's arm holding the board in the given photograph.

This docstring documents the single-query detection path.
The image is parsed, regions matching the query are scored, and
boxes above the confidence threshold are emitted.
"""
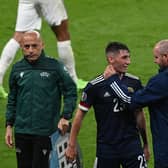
[56,63,77,119]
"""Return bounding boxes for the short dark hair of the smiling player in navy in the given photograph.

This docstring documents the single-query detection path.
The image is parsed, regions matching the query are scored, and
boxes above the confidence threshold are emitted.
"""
[105,41,130,54]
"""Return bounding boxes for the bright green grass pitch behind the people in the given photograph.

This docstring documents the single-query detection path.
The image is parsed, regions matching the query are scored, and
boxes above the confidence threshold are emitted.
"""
[0,0,168,168]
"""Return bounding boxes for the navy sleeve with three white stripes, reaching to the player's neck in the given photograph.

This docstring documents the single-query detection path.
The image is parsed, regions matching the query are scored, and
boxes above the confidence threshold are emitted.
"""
[110,74,168,110]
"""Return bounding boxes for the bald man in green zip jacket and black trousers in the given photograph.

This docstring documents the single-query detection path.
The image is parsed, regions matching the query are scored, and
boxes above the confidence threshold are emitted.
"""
[5,31,77,168]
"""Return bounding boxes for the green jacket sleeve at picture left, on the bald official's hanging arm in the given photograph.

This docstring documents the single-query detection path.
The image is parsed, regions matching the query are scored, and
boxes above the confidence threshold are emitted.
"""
[6,65,17,126]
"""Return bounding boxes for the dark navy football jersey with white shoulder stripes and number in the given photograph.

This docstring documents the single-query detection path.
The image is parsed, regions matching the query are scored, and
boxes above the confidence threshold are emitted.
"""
[79,74,142,158]
